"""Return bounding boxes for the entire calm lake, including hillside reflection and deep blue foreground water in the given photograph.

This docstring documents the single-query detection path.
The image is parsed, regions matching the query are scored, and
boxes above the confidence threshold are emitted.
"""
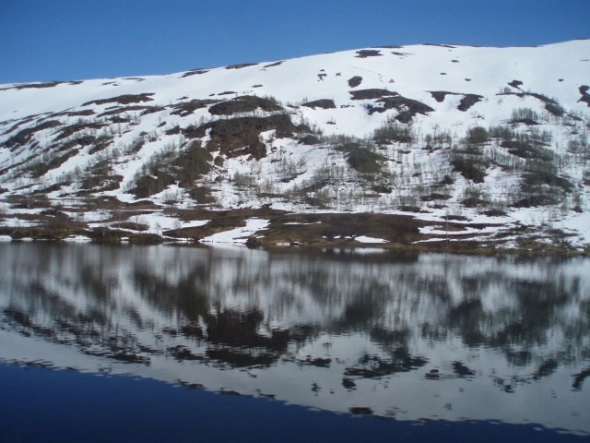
[0,243,590,442]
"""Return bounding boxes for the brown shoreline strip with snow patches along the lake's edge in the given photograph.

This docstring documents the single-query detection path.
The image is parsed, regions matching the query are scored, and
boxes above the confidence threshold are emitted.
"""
[0,208,590,257]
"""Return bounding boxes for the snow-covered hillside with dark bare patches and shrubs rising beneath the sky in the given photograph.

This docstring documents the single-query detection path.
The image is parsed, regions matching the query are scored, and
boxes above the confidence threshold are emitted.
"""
[0,40,590,250]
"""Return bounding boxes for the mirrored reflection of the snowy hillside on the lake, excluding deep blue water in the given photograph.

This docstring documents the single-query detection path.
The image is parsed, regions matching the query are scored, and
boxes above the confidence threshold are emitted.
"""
[0,243,590,432]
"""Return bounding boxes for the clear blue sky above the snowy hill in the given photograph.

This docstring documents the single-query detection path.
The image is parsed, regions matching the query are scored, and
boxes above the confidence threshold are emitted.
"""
[0,0,590,83]
